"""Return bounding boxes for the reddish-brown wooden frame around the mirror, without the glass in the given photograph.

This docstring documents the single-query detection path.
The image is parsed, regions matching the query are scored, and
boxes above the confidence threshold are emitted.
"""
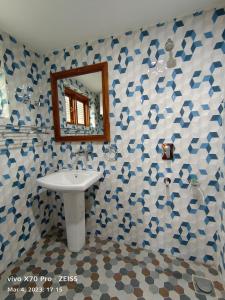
[50,62,110,142]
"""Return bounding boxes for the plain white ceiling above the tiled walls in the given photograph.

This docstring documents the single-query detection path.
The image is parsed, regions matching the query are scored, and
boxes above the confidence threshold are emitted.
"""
[0,0,225,53]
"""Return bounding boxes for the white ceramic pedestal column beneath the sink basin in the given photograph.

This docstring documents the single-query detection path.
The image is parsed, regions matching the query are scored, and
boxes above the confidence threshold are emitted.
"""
[62,191,85,252]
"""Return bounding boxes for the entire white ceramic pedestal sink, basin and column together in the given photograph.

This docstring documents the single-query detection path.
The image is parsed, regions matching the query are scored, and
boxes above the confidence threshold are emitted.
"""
[37,170,103,252]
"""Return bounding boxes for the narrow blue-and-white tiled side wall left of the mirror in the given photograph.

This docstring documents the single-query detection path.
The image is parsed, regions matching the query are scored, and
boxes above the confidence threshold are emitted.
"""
[0,33,58,273]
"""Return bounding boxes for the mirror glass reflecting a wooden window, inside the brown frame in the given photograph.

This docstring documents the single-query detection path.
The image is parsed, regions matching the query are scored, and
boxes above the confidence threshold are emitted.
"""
[57,72,103,135]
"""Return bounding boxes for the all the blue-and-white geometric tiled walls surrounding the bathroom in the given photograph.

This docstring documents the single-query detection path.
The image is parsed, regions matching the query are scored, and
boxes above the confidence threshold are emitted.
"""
[0,5,225,271]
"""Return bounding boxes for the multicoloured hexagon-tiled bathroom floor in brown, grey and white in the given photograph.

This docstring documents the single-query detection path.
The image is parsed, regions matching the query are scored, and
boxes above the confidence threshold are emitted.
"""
[0,230,225,300]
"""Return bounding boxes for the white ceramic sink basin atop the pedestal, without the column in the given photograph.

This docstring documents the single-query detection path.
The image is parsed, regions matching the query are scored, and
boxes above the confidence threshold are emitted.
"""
[37,170,102,191]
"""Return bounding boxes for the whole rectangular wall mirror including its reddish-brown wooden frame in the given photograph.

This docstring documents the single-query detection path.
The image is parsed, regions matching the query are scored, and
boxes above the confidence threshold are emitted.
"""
[51,62,110,142]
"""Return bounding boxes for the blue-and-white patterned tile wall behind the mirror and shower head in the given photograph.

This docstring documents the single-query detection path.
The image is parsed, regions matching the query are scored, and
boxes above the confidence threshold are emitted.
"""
[46,8,225,263]
